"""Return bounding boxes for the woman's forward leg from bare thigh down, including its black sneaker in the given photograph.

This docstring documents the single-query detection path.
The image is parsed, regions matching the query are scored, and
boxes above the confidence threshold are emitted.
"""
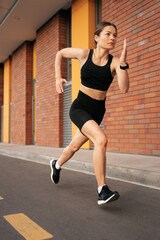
[81,120,119,205]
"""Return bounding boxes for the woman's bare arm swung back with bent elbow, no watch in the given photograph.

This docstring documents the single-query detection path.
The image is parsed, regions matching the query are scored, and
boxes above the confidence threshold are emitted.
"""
[55,48,88,93]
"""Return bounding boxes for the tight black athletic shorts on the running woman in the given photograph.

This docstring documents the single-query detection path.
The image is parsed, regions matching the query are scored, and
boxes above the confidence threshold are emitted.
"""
[69,91,106,134]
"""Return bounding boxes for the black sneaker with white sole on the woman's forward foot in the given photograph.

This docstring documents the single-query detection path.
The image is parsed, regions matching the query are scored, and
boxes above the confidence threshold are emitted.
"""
[98,185,119,205]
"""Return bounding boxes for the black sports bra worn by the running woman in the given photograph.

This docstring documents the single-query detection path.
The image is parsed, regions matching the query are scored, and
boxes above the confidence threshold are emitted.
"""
[81,49,113,91]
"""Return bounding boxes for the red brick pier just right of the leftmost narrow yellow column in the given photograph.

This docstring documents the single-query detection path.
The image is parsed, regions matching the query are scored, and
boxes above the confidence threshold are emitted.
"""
[11,42,33,144]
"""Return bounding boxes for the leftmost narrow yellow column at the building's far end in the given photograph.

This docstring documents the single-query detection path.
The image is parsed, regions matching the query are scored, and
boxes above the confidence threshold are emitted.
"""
[3,58,12,143]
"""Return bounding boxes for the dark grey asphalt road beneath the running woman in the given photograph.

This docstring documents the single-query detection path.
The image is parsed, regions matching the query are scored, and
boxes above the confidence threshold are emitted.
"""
[0,156,160,240]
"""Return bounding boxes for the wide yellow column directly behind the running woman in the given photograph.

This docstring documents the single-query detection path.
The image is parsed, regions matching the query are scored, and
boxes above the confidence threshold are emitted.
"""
[72,0,95,148]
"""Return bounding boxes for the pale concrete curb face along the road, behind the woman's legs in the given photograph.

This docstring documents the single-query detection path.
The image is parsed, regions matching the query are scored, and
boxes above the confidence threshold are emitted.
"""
[0,149,160,190]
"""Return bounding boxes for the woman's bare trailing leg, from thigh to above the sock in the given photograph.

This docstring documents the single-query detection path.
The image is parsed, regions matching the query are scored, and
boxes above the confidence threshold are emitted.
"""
[58,129,88,166]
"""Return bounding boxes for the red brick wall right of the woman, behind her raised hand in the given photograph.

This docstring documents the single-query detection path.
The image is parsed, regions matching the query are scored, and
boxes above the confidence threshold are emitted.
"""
[102,0,160,155]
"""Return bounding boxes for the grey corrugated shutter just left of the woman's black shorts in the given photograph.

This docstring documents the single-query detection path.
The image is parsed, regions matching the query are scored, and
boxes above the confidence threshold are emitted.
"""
[63,81,72,147]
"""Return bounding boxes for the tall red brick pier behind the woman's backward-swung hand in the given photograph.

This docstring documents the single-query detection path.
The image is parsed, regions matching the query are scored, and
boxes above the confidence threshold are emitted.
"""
[36,11,67,147]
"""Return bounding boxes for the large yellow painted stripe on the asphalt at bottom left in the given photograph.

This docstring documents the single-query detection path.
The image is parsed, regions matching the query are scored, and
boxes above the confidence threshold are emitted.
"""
[4,213,53,240]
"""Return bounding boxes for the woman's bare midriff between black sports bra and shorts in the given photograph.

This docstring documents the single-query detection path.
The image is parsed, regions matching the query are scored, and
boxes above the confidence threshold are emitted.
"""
[80,84,107,100]
